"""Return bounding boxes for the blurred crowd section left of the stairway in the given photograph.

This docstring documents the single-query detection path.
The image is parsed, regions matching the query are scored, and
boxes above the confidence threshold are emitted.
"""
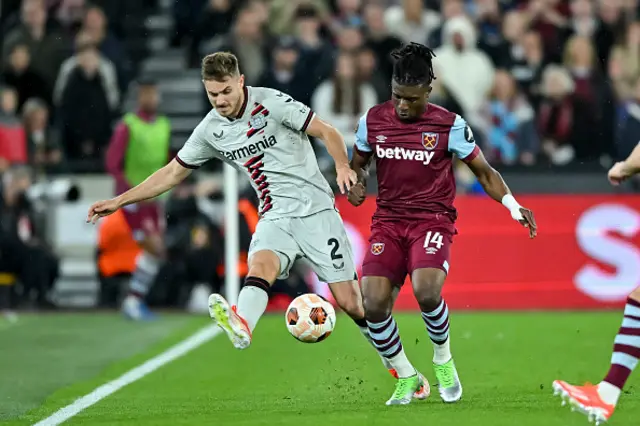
[0,0,153,173]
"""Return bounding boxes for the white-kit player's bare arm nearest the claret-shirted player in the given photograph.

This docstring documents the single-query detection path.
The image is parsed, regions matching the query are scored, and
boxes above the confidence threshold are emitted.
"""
[306,116,358,194]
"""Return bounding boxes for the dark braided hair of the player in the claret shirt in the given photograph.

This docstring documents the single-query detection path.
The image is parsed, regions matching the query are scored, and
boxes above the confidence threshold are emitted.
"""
[391,42,436,86]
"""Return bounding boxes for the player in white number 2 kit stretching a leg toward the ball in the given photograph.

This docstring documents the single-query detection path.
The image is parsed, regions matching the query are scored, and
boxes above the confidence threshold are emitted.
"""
[87,52,429,399]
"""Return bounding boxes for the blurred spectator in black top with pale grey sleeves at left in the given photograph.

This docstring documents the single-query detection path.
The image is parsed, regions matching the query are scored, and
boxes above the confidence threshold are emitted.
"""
[53,33,120,167]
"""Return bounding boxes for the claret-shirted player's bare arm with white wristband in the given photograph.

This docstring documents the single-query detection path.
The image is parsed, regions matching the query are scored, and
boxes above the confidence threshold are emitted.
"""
[467,151,538,238]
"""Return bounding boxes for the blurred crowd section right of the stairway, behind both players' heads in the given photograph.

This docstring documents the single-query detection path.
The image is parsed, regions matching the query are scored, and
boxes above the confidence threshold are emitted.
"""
[173,0,640,166]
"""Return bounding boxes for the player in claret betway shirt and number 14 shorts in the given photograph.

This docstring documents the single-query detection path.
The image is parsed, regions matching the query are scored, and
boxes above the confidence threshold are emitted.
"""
[349,43,537,405]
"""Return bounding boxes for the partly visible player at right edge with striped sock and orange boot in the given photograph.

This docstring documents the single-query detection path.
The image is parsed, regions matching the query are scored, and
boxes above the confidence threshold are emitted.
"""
[553,143,640,425]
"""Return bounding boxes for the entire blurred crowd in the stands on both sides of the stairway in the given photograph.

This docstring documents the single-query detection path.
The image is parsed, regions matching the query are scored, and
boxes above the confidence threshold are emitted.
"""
[0,0,640,172]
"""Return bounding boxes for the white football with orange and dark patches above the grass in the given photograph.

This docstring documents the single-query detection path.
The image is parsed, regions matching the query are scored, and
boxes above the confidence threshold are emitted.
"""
[285,293,336,343]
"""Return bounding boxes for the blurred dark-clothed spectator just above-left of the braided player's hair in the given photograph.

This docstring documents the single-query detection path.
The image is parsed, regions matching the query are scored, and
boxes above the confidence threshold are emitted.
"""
[364,1,402,80]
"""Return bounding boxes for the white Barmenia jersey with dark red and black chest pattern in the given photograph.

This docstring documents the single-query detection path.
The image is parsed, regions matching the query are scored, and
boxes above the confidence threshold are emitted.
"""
[176,87,334,218]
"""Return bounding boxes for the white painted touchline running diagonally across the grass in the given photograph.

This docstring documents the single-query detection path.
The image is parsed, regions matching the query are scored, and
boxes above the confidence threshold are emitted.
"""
[34,326,222,426]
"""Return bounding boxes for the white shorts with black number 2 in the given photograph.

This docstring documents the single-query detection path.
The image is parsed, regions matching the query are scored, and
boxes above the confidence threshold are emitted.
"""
[249,209,357,284]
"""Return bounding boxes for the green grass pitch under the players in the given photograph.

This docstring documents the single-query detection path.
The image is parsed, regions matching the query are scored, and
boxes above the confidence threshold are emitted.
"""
[0,312,640,426]
